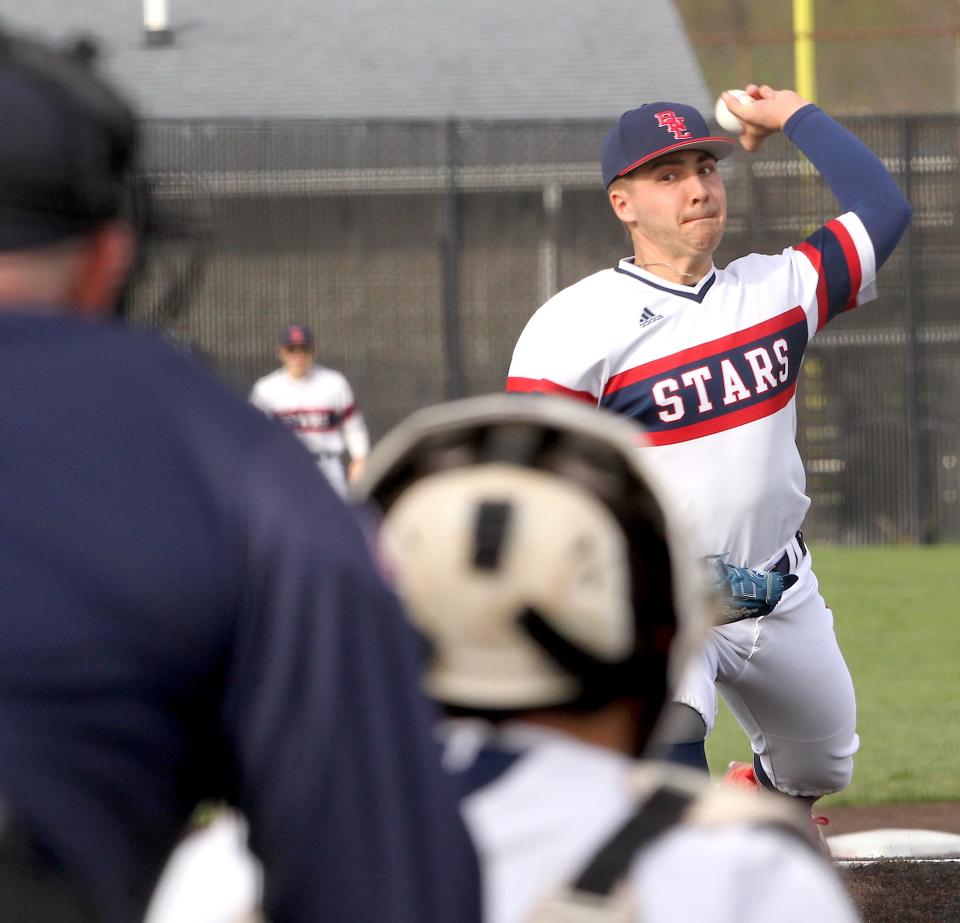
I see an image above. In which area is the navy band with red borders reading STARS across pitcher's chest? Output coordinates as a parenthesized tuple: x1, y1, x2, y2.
(600, 307, 808, 445)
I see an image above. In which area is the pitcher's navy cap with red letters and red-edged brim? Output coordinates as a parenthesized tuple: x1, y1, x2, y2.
(600, 103, 734, 186)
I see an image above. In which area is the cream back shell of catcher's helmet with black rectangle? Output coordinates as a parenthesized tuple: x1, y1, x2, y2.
(381, 464, 635, 709)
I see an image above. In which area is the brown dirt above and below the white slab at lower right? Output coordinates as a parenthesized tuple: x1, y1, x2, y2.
(824, 802, 960, 923)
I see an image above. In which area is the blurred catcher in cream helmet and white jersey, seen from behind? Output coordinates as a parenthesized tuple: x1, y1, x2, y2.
(359, 395, 856, 923)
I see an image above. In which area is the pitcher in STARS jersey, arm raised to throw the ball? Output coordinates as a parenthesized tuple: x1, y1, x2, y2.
(507, 85, 910, 832)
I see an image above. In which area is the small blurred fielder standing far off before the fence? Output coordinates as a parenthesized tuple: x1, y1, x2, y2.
(250, 324, 370, 497)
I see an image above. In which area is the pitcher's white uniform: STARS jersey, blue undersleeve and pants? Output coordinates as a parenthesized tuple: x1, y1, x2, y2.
(507, 97, 910, 797)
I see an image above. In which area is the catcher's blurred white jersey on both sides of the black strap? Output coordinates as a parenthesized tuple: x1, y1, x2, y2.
(445, 721, 857, 923)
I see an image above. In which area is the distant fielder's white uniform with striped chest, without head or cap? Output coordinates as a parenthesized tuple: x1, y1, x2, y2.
(250, 365, 370, 496)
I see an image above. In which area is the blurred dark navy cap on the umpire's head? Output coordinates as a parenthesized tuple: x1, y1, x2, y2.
(0, 29, 137, 251)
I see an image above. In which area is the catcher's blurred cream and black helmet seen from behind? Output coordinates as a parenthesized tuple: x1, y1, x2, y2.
(357, 395, 707, 711)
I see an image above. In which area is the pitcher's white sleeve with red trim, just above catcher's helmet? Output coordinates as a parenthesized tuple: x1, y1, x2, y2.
(506, 304, 605, 405)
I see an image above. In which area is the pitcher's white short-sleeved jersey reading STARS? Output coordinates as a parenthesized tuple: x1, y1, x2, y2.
(508, 213, 876, 567)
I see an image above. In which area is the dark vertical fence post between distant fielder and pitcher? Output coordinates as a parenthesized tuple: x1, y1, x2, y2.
(441, 119, 466, 400)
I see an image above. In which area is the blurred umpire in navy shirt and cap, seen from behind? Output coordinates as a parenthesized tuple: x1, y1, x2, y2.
(0, 27, 478, 923)
